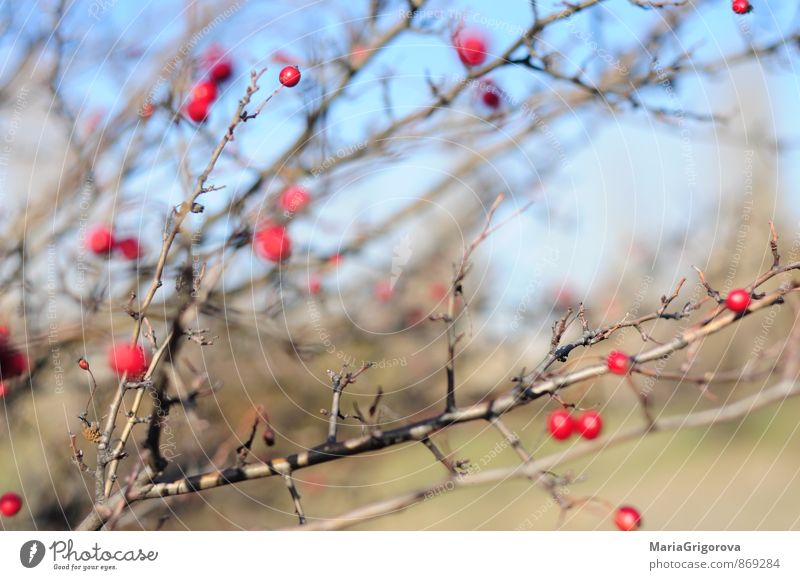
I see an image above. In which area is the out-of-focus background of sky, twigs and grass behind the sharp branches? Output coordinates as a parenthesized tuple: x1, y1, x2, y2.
(0, 0, 800, 530)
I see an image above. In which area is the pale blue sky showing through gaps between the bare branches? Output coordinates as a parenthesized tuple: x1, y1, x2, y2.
(3, 0, 800, 328)
